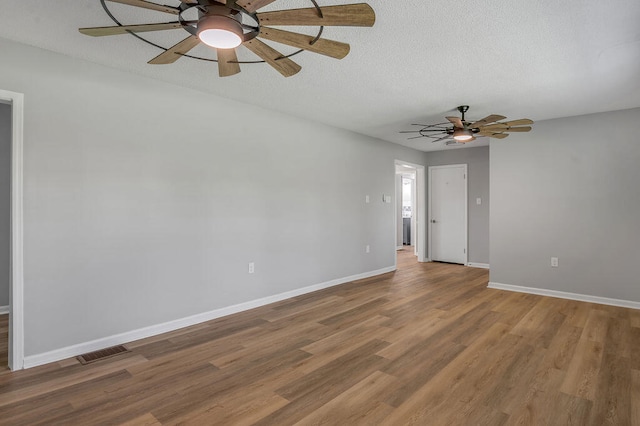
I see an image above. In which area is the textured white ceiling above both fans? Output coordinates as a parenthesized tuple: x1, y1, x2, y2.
(0, 0, 640, 151)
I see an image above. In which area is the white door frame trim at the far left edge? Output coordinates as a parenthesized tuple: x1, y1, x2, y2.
(0, 90, 24, 371)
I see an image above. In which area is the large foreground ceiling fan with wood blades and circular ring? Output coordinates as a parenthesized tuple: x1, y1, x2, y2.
(79, 0, 375, 77)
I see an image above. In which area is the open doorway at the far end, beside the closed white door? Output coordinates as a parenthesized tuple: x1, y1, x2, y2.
(394, 160, 427, 268)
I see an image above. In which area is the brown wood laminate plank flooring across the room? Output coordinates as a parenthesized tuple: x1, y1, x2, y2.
(0, 249, 640, 426)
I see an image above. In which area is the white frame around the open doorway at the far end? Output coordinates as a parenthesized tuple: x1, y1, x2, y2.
(393, 160, 429, 268)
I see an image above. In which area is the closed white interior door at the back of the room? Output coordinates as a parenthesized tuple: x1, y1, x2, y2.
(429, 164, 467, 264)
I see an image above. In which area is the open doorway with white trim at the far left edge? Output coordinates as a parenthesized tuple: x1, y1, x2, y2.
(0, 90, 24, 371)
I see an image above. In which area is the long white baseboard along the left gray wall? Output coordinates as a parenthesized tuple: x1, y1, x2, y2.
(24, 266, 396, 368)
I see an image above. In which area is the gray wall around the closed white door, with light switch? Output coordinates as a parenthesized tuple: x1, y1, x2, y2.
(425, 146, 493, 267)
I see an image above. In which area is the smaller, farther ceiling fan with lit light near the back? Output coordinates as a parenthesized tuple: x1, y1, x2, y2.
(400, 105, 533, 145)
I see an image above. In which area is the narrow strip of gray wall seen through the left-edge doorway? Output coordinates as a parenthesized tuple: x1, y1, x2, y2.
(0, 103, 11, 306)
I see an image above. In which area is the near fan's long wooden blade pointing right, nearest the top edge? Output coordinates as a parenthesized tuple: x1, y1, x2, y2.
(258, 3, 376, 27)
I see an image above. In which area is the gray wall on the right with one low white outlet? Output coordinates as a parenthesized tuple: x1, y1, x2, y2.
(491, 108, 640, 302)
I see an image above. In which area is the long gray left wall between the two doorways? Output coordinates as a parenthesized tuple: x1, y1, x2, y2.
(0, 39, 423, 355)
